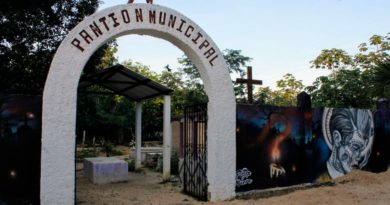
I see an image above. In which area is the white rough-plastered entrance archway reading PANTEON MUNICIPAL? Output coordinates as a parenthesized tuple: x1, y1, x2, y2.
(41, 4, 236, 204)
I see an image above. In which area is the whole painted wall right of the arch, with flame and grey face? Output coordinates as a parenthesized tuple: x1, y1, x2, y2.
(236, 105, 390, 191)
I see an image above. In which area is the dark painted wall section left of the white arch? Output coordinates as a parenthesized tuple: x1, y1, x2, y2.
(0, 94, 42, 204)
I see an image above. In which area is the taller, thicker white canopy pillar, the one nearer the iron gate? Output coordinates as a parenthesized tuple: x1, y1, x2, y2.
(163, 95, 172, 181)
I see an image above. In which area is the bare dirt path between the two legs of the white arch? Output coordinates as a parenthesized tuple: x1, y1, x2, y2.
(76, 168, 200, 205)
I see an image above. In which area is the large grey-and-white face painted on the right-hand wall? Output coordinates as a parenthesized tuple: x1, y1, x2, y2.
(323, 109, 374, 178)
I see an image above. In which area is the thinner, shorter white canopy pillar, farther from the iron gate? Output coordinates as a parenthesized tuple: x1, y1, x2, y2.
(135, 102, 142, 169)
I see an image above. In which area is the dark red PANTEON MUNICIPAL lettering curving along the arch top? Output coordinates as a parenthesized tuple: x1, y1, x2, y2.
(70, 7, 219, 66)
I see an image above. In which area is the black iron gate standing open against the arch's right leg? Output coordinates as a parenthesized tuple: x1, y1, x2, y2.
(183, 104, 208, 201)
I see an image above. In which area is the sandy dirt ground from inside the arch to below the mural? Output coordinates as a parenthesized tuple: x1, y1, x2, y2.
(76, 162, 390, 205)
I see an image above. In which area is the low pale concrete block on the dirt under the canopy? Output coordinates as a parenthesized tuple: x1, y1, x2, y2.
(84, 157, 128, 184)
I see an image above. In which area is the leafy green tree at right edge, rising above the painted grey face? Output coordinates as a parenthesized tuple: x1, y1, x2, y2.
(306, 33, 390, 108)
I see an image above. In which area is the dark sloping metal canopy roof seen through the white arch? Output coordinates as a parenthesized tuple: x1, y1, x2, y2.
(79, 64, 173, 102)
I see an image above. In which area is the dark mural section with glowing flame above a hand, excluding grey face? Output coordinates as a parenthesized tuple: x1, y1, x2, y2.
(236, 105, 331, 191)
